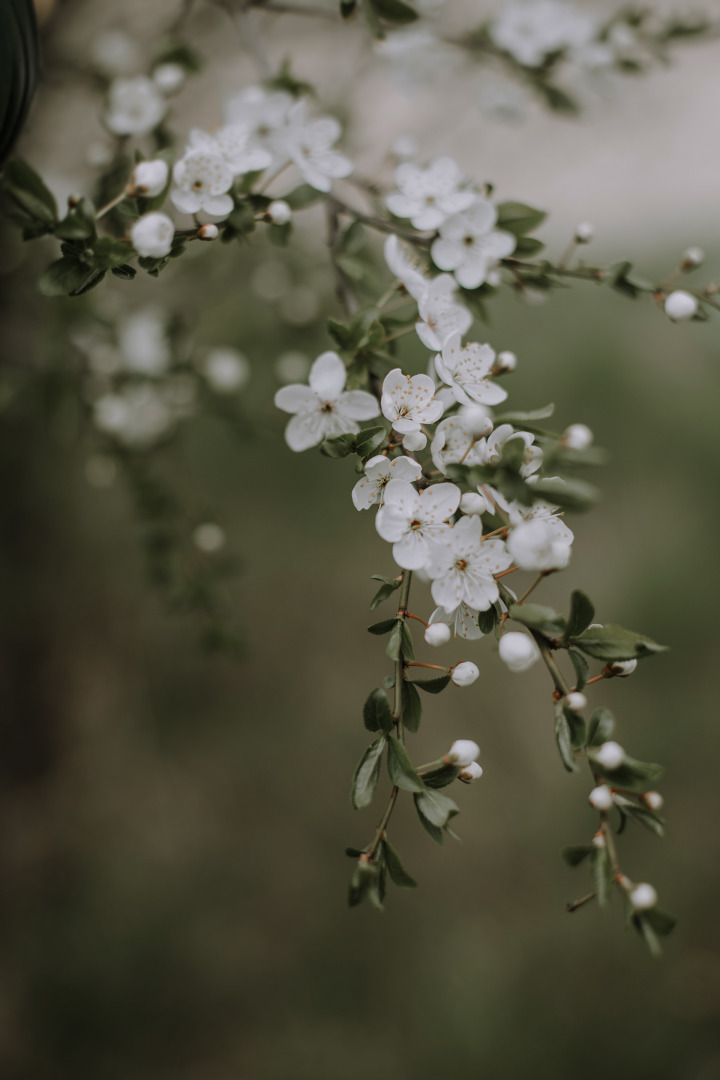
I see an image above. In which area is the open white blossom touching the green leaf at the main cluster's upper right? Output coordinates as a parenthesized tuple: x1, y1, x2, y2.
(431, 198, 517, 288)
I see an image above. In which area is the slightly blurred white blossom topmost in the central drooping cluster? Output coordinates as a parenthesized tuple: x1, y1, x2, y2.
(385, 157, 476, 230)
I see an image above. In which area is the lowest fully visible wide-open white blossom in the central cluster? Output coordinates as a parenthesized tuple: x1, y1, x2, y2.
(425, 517, 512, 611)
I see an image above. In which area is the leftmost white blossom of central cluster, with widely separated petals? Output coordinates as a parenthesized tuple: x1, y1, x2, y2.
(275, 352, 379, 451)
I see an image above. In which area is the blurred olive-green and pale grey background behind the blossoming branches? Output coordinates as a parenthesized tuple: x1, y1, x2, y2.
(0, 0, 720, 1080)
